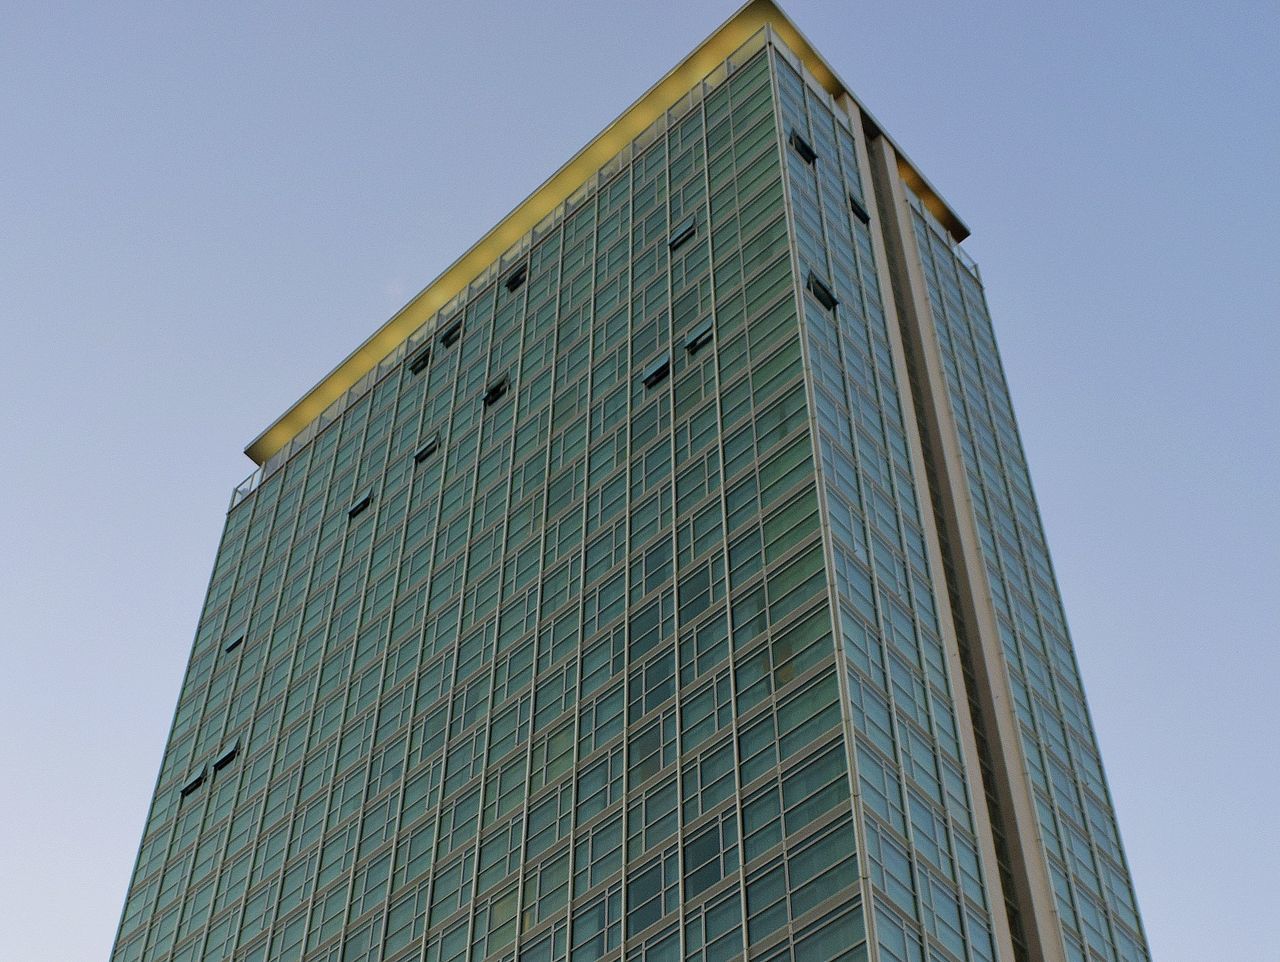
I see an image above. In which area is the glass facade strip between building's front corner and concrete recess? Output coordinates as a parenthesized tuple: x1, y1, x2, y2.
(778, 48, 995, 962)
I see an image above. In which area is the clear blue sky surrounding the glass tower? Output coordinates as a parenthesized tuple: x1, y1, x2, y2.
(0, 0, 1280, 962)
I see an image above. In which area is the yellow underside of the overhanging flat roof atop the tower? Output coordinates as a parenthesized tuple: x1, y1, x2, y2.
(244, 0, 969, 464)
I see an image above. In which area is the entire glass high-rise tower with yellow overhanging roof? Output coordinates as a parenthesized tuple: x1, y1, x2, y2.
(113, 1, 1148, 962)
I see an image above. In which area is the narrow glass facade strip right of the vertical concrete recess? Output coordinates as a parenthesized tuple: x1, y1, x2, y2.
(911, 202, 1149, 962)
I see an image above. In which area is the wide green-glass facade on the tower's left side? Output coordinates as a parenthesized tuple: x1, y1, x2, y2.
(114, 41, 863, 962)
